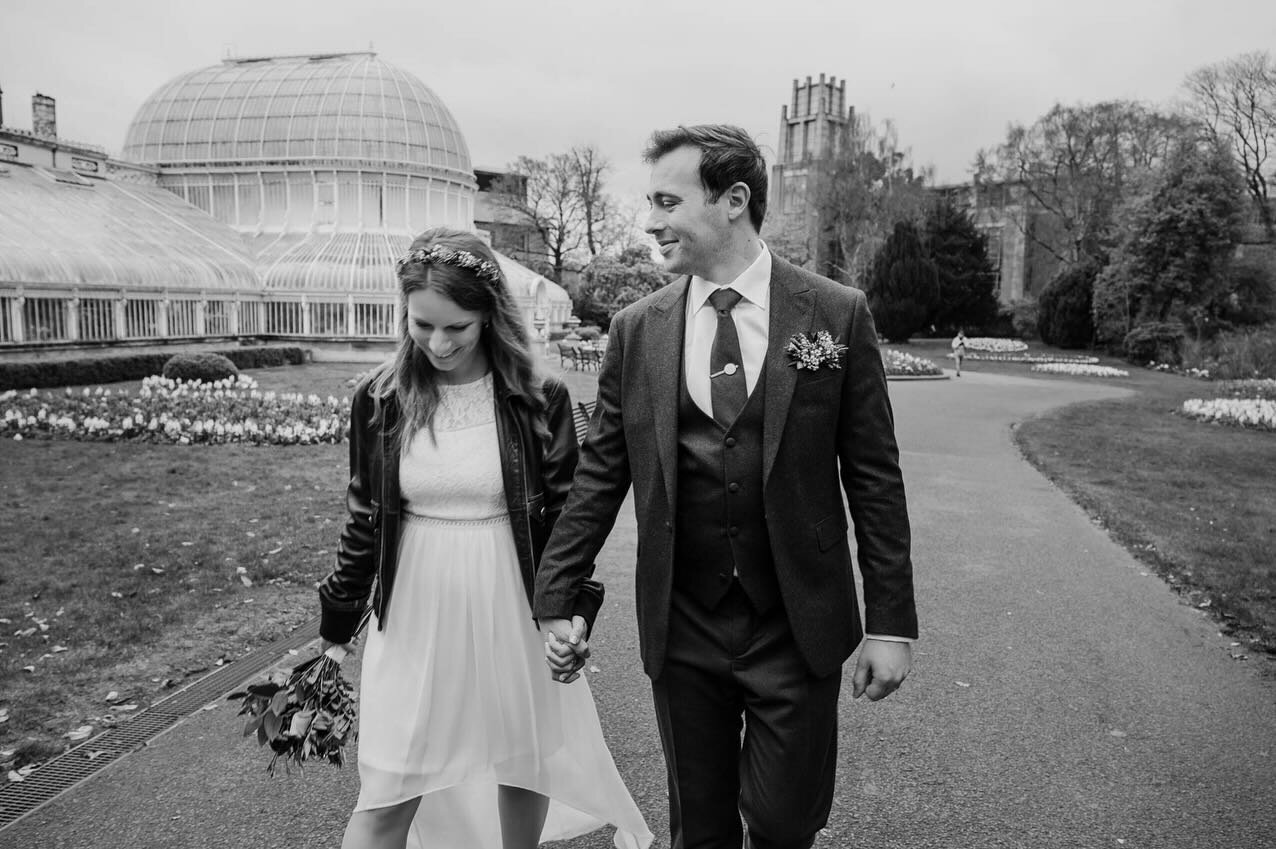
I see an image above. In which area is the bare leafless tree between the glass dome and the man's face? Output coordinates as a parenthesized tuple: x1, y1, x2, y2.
(493, 153, 584, 281)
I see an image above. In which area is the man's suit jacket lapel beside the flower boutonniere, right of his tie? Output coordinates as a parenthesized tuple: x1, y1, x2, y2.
(762, 255, 815, 486)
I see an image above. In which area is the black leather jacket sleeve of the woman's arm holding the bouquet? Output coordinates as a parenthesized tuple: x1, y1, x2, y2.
(319, 383, 380, 643)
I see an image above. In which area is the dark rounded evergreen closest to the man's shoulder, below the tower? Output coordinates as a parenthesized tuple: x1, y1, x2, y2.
(865, 221, 939, 342)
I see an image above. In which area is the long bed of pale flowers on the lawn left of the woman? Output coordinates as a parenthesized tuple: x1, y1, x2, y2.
(0, 375, 350, 446)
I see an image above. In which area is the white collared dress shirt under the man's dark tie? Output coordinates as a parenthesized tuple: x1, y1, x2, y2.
(683, 245, 771, 416)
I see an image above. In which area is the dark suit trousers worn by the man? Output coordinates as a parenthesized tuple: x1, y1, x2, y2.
(652, 582, 842, 849)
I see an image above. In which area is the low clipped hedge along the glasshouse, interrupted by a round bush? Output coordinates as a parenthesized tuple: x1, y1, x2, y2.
(0, 347, 306, 392)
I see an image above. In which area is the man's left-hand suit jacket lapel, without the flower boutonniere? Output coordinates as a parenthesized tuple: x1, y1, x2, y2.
(642, 277, 690, 507)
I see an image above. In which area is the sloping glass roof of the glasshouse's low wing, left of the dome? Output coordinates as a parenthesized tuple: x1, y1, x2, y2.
(0, 166, 260, 291)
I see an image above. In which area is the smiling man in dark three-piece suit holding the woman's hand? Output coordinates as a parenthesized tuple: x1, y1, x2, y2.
(533, 125, 917, 849)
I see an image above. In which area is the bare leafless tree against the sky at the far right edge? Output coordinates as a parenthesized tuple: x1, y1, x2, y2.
(1183, 51, 1276, 236)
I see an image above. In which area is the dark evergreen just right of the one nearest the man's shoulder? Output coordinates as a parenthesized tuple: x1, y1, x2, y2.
(925, 198, 998, 334)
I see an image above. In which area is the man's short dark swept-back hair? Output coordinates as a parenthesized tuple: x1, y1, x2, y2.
(643, 124, 767, 232)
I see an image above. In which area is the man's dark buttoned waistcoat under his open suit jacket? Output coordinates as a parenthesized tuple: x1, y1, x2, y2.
(674, 372, 780, 613)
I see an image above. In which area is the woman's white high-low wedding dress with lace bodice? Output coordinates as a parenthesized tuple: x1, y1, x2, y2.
(356, 375, 652, 849)
